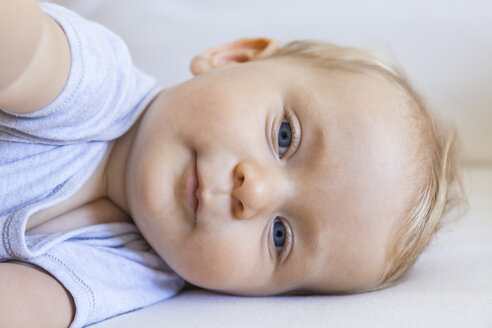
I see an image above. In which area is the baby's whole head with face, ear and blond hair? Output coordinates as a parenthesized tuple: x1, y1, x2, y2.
(126, 39, 461, 295)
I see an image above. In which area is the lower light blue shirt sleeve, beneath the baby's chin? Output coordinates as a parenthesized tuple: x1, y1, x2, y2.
(24, 223, 184, 328)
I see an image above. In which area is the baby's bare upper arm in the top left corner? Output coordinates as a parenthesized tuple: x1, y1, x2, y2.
(0, 0, 70, 113)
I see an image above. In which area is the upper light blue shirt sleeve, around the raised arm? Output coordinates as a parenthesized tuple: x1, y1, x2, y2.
(0, 3, 159, 145)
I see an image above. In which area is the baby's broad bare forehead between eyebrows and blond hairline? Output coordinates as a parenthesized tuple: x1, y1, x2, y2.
(276, 65, 416, 290)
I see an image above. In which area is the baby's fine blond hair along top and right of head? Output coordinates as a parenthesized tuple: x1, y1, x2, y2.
(274, 41, 468, 292)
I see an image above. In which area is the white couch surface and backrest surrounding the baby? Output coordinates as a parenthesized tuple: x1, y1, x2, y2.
(47, 0, 492, 328)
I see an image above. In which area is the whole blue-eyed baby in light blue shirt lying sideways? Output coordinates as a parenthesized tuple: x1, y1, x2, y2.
(0, 0, 461, 327)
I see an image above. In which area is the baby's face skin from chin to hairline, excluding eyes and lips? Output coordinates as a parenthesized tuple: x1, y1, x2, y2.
(108, 53, 416, 296)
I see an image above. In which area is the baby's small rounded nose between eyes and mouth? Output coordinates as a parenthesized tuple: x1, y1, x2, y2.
(232, 162, 283, 219)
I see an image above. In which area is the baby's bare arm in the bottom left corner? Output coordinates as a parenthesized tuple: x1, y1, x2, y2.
(0, 262, 75, 328)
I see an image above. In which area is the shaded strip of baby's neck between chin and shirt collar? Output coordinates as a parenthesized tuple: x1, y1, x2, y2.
(104, 115, 143, 215)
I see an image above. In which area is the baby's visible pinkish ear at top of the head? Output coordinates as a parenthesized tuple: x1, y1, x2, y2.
(190, 38, 279, 75)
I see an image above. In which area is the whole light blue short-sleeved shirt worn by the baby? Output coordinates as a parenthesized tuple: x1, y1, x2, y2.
(0, 3, 184, 327)
